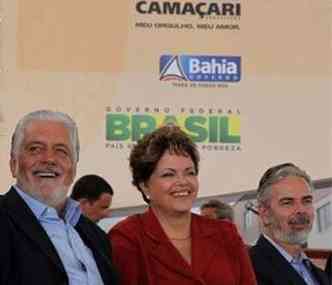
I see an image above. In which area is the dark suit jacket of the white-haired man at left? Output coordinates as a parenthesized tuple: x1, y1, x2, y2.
(0, 188, 117, 285)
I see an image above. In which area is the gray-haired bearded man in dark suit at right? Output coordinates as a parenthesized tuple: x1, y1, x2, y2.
(250, 163, 330, 285)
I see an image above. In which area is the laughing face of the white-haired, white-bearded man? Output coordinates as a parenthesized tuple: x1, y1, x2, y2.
(10, 120, 76, 210)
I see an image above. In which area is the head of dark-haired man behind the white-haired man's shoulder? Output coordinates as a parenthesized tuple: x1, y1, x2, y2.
(71, 174, 114, 223)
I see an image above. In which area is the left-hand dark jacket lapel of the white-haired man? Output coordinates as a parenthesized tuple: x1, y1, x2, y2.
(3, 188, 65, 273)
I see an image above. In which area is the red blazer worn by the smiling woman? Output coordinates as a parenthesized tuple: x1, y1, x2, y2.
(110, 206, 256, 285)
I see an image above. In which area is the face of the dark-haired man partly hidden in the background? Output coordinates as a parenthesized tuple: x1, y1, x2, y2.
(80, 193, 112, 223)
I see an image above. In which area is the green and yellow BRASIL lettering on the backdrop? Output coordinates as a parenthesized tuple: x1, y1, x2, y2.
(106, 113, 241, 144)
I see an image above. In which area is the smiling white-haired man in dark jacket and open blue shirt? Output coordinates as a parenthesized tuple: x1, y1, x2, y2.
(0, 110, 118, 285)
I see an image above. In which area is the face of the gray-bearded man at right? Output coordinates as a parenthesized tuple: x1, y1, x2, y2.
(259, 176, 314, 245)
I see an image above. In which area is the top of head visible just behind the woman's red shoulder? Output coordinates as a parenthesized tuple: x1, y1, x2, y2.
(200, 200, 234, 222)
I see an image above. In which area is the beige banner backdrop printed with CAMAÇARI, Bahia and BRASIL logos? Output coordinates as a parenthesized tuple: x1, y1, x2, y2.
(0, 0, 332, 207)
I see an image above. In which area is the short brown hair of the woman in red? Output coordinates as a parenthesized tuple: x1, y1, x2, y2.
(129, 124, 199, 203)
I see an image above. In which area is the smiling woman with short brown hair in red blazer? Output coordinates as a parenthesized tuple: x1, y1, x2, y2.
(109, 125, 256, 285)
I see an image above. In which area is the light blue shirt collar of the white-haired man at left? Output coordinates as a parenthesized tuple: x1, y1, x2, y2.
(14, 185, 82, 226)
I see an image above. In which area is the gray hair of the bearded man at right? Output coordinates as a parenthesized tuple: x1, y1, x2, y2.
(257, 162, 314, 205)
